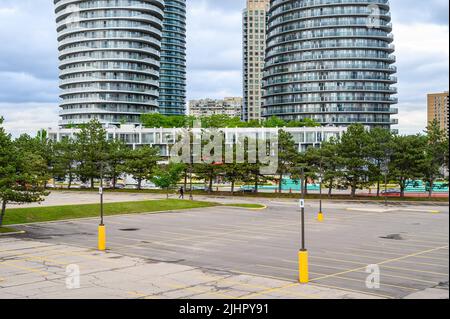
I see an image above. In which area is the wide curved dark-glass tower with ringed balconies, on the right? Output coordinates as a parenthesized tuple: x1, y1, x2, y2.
(263, 0, 397, 128)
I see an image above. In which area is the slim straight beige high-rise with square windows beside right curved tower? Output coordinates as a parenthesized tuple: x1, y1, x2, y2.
(242, 0, 270, 121)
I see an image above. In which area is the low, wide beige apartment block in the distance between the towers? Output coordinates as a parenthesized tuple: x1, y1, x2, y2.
(189, 97, 242, 117)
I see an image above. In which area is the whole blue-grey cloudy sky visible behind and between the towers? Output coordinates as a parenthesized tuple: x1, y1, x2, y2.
(0, 0, 449, 136)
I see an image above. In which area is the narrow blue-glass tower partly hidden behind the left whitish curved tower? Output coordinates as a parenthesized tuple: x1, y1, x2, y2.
(159, 0, 186, 115)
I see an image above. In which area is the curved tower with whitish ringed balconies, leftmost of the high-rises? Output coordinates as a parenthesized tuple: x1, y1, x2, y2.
(54, 0, 164, 126)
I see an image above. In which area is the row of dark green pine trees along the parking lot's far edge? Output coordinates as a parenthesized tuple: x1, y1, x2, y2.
(0, 116, 449, 225)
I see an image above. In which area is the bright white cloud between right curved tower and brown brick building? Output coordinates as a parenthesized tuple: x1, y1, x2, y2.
(394, 23, 449, 134)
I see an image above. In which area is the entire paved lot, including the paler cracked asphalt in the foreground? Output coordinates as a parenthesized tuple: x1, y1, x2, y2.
(0, 194, 449, 299)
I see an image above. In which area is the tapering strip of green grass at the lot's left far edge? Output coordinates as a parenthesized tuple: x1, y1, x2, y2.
(0, 199, 220, 228)
